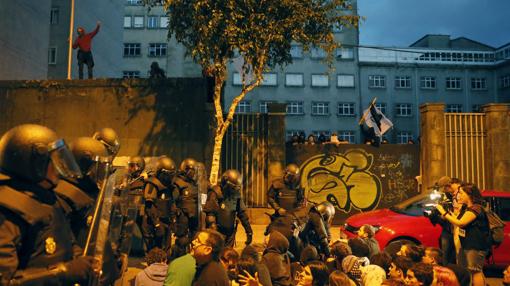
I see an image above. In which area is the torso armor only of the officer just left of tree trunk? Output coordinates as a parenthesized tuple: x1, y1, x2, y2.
(174, 175, 198, 217)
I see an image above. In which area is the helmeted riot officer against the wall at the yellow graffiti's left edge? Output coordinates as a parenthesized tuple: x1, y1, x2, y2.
(267, 164, 304, 215)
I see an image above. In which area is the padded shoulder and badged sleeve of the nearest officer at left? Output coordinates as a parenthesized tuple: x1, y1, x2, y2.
(0, 181, 74, 271)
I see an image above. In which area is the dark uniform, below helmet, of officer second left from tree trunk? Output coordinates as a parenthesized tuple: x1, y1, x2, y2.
(142, 176, 175, 250)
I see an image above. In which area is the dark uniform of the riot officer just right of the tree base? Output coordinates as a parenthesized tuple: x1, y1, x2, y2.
(204, 186, 253, 247)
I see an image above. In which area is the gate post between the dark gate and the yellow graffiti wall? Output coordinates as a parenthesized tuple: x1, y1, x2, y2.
(267, 103, 286, 186)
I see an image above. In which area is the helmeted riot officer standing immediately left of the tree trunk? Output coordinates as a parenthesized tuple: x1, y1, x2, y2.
(174, 158, 200, 238)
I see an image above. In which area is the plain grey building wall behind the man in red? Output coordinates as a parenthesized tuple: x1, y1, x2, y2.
(48, 0, 125, 79)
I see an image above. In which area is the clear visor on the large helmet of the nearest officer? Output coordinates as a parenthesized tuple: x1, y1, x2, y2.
(48, 139, 82, 179)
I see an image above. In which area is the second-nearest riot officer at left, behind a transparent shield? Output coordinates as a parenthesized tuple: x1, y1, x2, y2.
(55, 137, 119, 285)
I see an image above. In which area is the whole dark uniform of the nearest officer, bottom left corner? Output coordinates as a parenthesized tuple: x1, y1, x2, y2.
(0, 173, 81, 285)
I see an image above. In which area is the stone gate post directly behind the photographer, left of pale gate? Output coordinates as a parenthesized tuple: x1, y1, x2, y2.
(420, 103, 446, 190)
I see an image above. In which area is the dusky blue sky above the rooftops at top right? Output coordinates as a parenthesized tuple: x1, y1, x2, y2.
(358, 0, 510, 48)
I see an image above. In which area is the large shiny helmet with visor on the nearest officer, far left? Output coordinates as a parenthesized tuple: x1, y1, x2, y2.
(0, 124, 81, 183)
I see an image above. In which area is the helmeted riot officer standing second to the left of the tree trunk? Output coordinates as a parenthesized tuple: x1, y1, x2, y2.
(142, 156, 177, 250)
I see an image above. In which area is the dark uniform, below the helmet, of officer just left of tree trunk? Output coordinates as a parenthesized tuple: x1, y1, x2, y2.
(173, 174, 199, 238)
